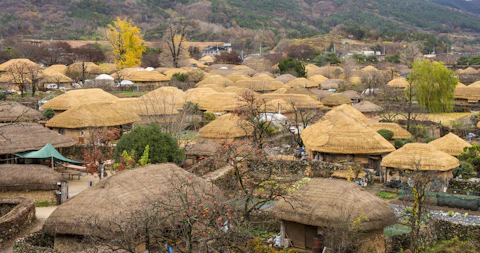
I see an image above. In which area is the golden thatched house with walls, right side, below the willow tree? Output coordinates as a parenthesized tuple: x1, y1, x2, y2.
(381, 143, 460, 190)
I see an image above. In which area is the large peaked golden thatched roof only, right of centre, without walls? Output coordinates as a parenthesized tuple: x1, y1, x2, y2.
(301, 111, 395, 155)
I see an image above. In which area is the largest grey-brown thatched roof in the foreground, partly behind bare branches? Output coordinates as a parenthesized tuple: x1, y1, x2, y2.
(43, 163, 222, 237)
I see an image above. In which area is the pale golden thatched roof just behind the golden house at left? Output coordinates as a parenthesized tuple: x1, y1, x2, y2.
(42, 89, 119, 111)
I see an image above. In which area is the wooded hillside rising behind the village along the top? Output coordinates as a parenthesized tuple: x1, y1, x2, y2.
(0, 0, 480, 48)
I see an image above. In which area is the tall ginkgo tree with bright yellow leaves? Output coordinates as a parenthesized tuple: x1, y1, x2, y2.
(106, 18, 146, 69)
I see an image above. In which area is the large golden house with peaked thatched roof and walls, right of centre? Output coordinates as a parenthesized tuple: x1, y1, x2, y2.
(301, 110, 395, 170)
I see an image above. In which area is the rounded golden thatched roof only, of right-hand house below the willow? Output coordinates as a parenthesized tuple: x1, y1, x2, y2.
(381, 143, 460, 171)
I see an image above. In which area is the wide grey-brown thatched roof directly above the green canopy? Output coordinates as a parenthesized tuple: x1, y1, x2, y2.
(0, 123, 77, 154)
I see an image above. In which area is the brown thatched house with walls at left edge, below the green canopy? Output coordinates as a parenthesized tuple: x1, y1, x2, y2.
(0, 164, 68, 204)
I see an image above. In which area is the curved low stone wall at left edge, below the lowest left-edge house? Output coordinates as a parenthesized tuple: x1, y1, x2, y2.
(0, 198, 35, 246)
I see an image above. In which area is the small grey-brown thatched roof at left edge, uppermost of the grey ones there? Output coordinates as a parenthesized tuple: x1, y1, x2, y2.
(0, 101, 43, 122)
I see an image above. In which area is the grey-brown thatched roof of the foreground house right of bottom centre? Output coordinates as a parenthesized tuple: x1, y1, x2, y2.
(268, 178, 396, 231)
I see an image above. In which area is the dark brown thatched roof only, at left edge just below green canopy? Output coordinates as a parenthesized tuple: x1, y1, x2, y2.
(0, 164, 65, 191)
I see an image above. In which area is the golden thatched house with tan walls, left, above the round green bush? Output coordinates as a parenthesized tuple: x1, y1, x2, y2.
(46, 102, 142, 143)
